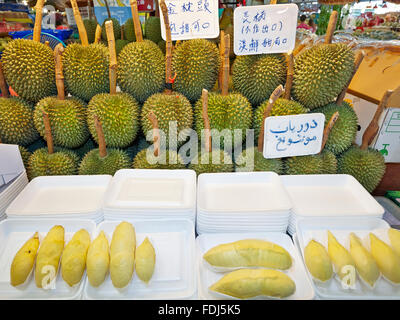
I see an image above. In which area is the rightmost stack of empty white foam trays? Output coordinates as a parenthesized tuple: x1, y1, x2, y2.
(281, 174, 385, 235)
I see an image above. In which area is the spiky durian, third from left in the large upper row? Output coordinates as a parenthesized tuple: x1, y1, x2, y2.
(117, 40, 165, 103)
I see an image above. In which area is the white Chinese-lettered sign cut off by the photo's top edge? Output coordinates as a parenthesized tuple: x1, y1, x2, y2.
(160, 0, 219, 41)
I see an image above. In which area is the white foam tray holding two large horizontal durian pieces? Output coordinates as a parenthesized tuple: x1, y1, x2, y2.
(196, 232, 315, 300)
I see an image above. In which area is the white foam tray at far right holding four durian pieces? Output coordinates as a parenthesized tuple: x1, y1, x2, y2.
(296, 218, 400, 299)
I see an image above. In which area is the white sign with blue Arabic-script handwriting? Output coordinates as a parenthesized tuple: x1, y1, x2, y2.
(263, 113, 325, 159)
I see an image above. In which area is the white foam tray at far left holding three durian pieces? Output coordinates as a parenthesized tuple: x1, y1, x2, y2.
(0, 219, 96, 300)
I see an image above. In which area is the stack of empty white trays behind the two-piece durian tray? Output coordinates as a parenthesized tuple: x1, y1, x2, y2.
(196, 172, 291, 234)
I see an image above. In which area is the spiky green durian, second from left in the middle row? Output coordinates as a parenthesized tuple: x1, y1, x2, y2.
(33, 97, 89, 148)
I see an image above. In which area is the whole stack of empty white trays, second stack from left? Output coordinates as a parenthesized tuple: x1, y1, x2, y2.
(103, 169, 196, 224)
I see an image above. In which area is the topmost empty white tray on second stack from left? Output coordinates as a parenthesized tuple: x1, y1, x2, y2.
(104, 169, 196, 212)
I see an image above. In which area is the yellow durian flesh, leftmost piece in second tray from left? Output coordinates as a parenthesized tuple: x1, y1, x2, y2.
(86, 231, 110, 287)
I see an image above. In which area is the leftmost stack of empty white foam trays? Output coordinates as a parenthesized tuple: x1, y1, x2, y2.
(6, 175, 111, 223)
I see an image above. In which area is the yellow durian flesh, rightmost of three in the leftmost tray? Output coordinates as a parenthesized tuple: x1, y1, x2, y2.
(61, 229, 90, 287)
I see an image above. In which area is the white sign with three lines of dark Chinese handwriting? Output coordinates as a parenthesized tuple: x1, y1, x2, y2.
(233, 3, 299, 56)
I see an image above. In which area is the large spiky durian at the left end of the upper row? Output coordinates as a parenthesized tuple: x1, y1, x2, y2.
(1, 39, 57, 103)
